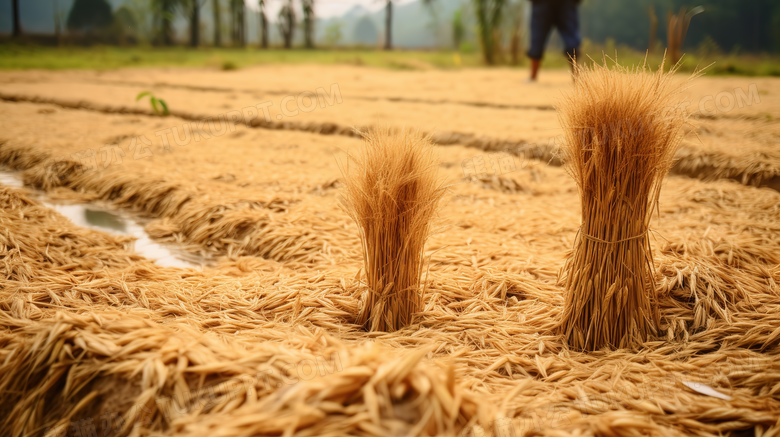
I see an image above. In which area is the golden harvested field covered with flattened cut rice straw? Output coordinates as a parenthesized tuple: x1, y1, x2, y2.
(0, 65, 780, 437)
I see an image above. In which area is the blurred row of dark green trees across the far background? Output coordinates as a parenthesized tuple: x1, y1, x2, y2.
(6, 0, 780, 57)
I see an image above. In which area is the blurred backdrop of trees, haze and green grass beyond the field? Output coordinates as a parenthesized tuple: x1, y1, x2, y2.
(0, 0, 780, 76)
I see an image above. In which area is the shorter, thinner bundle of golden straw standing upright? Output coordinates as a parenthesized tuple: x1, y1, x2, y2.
(341, 128, 445, 332)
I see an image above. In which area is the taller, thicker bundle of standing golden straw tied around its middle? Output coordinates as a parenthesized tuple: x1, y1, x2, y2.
(558, 60, 696, 350)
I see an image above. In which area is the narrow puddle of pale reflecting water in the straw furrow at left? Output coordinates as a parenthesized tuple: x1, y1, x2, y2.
(0, 171, 203, 270)
